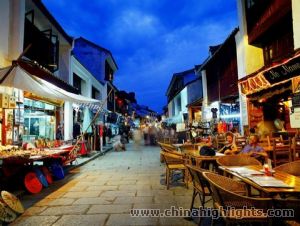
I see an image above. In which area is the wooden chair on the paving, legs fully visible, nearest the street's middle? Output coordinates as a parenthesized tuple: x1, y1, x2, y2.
(161, 151, 188, 189)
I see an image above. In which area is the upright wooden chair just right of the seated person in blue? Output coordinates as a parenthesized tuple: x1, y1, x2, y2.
(273, 138, 292, 167)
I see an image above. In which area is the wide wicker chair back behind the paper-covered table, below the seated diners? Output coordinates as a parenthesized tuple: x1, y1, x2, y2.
(217, 155, 262, 166)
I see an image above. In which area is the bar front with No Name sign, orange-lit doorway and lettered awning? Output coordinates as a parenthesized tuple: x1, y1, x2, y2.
(239, 53, 300, 136)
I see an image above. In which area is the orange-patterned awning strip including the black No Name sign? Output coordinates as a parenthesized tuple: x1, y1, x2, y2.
(239, 52, 300, 95)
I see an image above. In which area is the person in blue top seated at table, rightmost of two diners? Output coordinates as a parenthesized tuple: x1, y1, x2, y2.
(240, 134, 268, 161)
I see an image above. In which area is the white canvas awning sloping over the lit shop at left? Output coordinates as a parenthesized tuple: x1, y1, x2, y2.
(0, 64, 100, 104)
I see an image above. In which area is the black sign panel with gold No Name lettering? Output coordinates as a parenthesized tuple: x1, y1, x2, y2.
(263, 56, 300, 84)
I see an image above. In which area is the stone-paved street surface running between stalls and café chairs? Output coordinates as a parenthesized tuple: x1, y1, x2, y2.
(12, 144, 211, 226)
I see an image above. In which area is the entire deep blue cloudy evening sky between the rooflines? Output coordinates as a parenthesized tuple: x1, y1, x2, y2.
(43, 0, 238, 112)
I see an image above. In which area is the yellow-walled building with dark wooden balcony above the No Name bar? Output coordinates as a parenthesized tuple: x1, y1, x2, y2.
(236, 0, 300, 135)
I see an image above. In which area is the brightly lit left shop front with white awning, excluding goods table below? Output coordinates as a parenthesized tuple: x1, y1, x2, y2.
(0, 61, 100, 145)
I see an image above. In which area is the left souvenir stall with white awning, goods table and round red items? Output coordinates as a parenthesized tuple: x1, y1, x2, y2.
(0, 60, 99, 193)
